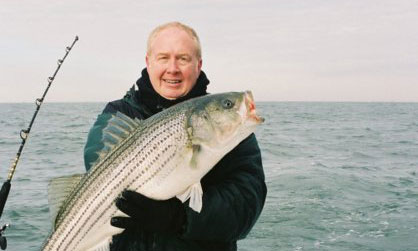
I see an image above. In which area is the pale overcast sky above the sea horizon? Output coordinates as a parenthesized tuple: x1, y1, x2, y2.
(0, 0, 418, 103)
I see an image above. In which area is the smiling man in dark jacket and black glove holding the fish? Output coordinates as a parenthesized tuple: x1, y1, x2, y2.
(84, 22, 267, 251)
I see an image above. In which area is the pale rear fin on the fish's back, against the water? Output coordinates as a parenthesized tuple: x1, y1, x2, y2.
(48, 174, 84, 226)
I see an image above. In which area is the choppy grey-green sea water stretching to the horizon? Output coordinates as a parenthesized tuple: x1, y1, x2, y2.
(0, 102, 418, 251)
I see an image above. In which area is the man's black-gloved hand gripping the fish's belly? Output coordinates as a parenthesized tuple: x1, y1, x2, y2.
(110, 190, 186, 233)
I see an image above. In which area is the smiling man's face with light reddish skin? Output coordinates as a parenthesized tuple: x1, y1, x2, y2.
(145, 27, 202, 99)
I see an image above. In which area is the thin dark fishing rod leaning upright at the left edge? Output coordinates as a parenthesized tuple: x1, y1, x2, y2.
(0, 36, 78, 250)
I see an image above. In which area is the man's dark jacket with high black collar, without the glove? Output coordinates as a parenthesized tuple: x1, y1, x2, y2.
(84, 69, 267, 251)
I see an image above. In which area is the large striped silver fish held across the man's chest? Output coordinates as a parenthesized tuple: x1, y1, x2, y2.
(42, 91, 264, 251)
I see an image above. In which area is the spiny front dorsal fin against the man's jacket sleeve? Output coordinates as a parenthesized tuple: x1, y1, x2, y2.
(92, 112, 141, 166)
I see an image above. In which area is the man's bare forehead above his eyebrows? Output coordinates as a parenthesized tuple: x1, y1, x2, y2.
(150, 27, 197, 54)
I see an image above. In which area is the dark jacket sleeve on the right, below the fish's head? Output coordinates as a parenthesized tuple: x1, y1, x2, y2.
(182, 134, 267, 241)
